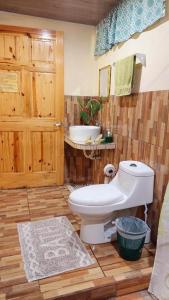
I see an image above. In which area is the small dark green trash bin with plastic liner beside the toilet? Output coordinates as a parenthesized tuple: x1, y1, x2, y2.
(115, 217, 148, 260)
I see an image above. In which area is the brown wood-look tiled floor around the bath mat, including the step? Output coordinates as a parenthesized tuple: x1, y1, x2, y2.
(0, 187, 154, 300)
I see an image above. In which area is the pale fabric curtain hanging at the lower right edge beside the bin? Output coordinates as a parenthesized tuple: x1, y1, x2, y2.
(148, 183, 169, 300)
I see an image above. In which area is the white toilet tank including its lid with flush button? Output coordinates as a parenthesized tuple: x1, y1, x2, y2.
(111, 160, 154, 206)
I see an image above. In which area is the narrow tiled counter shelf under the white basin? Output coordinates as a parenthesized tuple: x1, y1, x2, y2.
(65, 136, 115, 151)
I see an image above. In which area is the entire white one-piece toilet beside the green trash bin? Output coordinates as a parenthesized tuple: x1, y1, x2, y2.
(69, 161, 154, 244)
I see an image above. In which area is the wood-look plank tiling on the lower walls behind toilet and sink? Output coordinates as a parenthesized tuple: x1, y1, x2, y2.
(65, 91, 169, 241)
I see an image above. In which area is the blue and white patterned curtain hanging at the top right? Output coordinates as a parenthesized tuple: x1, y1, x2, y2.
(95, 0, 165, 55)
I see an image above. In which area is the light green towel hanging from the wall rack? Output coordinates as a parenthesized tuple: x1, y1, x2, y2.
(115, 55, 135, 96)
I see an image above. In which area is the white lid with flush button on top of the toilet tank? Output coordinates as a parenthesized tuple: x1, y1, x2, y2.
(119, 160, 154, 177)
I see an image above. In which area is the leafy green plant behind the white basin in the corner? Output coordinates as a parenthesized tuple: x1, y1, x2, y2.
(78, 98, 102, 125)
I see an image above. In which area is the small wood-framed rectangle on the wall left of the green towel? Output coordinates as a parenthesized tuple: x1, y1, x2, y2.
(99, 65, 111, 97)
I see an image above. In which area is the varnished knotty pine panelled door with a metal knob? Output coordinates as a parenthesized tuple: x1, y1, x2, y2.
(0, 25, 64, 188)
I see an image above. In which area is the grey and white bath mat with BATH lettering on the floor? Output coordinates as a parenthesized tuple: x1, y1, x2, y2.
(17, 216, 95, 281)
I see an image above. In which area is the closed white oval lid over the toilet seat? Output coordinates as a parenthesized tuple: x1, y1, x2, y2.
(69, 184, 123, 206)
